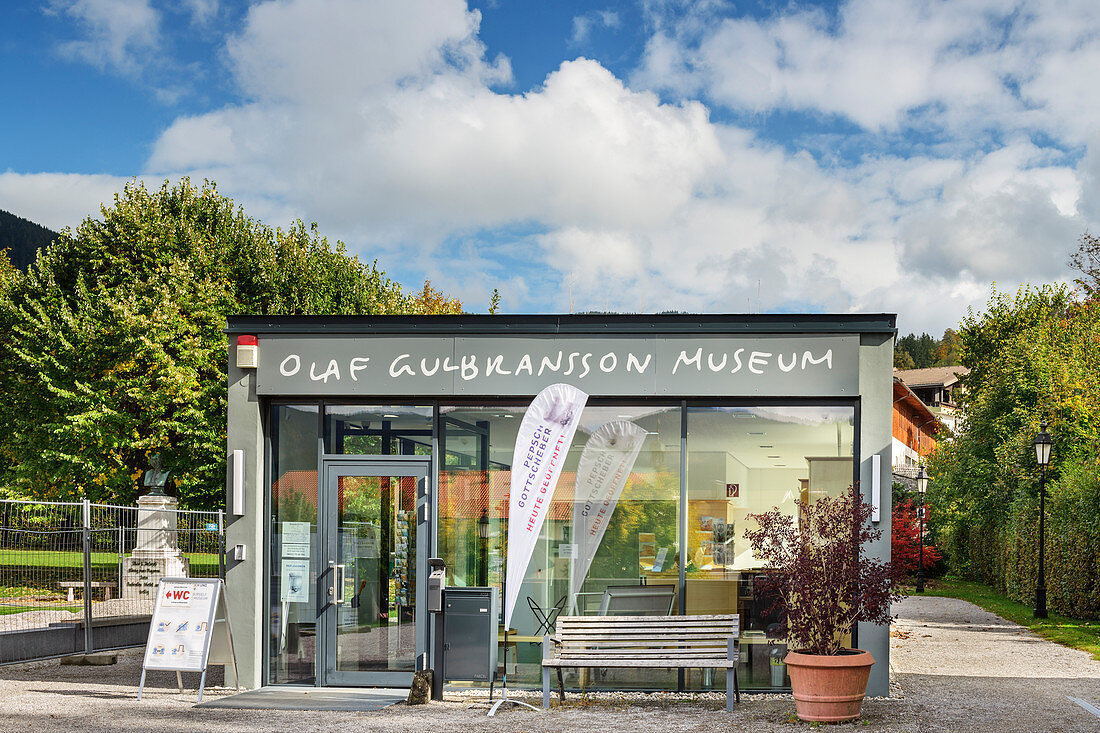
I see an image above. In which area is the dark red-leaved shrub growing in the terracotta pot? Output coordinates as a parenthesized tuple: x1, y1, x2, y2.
(745, 488, 902, 655)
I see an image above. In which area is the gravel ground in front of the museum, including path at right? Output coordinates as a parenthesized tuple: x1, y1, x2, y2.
(0, 598, 1100, 733)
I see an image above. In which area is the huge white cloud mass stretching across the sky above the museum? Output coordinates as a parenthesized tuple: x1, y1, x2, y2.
(19, 0, 1100, 332)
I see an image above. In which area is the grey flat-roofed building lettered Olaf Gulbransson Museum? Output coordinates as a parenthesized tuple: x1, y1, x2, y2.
(227, 314, 895, 696)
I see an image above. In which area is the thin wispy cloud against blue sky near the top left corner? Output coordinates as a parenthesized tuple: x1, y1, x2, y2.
(50, 0, 161, 75)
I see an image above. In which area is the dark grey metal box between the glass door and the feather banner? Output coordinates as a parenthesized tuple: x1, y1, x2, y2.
(443, 588, 499, 682)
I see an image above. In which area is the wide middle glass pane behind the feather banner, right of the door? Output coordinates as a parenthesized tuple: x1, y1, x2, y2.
(439, 405, 677, 688)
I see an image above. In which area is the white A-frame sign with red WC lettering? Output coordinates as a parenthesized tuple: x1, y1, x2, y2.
(138, 578, 237, 702)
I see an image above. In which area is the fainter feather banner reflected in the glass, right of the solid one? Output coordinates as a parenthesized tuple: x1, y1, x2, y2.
(569, 420, 646, 613)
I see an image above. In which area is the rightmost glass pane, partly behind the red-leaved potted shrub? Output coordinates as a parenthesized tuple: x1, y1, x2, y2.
(686, 406, 855, 689)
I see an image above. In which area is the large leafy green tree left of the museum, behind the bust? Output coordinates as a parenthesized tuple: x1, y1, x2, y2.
(0, 179, 461, 507)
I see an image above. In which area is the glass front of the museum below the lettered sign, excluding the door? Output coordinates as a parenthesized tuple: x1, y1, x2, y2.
(268, 400, 856, 689)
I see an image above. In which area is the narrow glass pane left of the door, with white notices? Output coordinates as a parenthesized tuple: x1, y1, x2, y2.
(267, 405, 319, 685)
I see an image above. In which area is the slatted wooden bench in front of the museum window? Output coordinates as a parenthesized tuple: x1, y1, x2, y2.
(542, 614, 741, 710)
